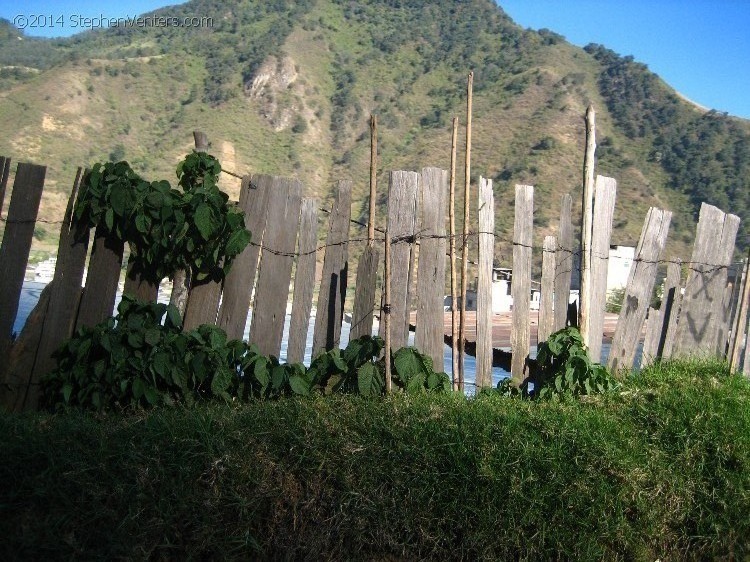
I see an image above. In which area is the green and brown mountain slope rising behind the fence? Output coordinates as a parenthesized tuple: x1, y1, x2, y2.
(0, 0, 750, 264)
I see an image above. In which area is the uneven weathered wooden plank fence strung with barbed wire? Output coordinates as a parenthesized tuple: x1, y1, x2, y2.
(0, 121, 750, 410)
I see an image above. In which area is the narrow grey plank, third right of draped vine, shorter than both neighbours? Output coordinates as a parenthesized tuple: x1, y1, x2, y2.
(286, 199, 320, 363)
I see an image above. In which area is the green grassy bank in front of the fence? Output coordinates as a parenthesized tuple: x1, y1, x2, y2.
(0, 356, 750, 560)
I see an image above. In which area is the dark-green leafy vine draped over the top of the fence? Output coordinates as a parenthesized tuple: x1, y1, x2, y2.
(75, 152, 250, 283)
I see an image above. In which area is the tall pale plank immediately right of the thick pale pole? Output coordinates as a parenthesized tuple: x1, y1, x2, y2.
(587, 176, 617, 363)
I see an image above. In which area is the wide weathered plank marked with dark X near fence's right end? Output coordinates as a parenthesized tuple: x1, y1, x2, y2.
(674, 203, 740, 355)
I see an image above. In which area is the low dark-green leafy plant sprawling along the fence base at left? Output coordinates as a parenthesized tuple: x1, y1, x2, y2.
(43, 310, 450, 411)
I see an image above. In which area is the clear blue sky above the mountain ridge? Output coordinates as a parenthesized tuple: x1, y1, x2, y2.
(0, 0, 750, 119)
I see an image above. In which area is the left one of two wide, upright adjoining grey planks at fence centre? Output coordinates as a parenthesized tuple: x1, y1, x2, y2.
(381, 171, 421, 350)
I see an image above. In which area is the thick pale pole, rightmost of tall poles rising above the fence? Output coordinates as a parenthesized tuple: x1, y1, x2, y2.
(578, 105, 596, 347)
